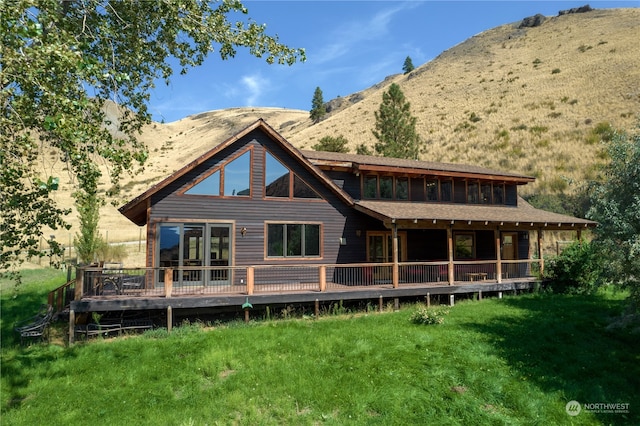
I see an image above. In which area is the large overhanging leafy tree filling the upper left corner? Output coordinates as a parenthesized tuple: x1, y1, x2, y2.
(0, 0, 305, 280)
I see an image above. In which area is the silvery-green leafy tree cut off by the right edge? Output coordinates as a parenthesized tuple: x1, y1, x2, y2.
(588, 125, 640, 310)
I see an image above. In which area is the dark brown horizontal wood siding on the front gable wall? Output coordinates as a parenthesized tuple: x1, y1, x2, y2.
(150, 132, 364, 265)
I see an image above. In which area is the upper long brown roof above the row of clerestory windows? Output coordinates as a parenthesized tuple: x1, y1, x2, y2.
(301, 150, 535, 184)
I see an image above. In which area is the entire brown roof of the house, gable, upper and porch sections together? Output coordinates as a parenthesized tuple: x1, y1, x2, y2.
(119, 119, 597, 229)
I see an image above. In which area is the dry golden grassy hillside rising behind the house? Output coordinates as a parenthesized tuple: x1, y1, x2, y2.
(37, 9, 640, 250)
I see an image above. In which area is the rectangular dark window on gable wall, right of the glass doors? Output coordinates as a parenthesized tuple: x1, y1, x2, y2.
(266, 223, 321, 257)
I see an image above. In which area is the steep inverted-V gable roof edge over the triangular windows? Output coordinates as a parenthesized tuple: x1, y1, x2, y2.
(118, 119, 353, 226)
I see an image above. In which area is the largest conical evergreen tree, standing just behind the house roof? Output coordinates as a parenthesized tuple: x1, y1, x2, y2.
(373, 83, 423, 159)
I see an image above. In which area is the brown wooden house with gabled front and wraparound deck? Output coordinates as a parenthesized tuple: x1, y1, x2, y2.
(62, 120, 596, 336)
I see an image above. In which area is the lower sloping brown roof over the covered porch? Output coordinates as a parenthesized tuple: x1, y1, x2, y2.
(355, 197, 597, 229)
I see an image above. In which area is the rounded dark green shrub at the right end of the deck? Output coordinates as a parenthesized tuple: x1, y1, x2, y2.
(544, 241, 602, 294)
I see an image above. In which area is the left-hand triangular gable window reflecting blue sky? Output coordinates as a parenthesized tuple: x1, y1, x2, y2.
(184, 151, 251, 197)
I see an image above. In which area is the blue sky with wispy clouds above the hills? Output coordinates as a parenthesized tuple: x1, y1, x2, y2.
(150, 0, 640, 122)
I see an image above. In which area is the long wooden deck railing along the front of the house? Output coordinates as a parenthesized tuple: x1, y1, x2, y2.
(75, 259, 540, 298)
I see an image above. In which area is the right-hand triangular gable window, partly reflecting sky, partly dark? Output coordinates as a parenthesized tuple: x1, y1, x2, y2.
(264, 152, 321, 199)
